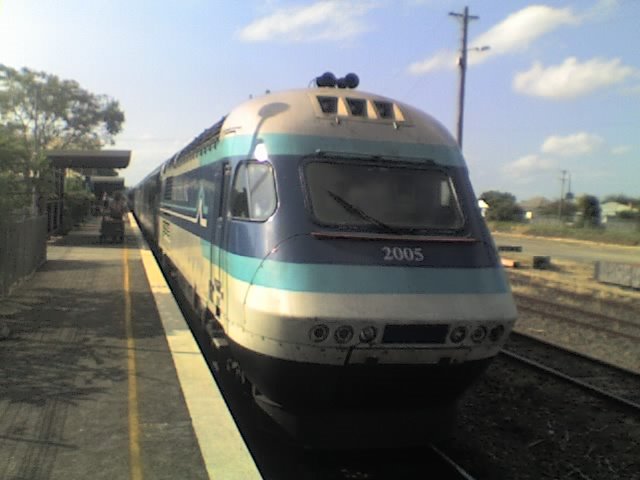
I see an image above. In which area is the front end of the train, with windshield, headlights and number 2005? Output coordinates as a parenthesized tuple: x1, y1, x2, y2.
(222, 83, 516, 444)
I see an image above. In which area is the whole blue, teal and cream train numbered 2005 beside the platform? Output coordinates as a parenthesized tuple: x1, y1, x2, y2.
(131, 73, 517, 444)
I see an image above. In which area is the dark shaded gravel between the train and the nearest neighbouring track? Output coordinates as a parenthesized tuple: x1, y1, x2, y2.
(443, 357, 640, 480)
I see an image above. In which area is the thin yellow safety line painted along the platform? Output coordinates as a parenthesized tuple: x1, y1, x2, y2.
(122, 246, 142, 480)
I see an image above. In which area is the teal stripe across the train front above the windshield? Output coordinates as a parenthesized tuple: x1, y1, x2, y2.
(200, 134, 465, 167)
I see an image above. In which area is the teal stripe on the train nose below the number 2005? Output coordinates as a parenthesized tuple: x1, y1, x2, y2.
(202, 241, 509, 294)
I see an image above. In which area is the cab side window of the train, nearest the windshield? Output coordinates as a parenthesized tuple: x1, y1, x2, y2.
(230, 162, 277, 221)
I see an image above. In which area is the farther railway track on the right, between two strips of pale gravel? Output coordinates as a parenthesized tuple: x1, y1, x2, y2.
(514, 293, 640, 342)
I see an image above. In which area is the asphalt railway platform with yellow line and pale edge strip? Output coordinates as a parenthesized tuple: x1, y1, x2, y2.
(0, 216, 261, 480)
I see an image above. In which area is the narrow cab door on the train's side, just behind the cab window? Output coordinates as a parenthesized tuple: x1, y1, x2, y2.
(209, 162, 231, 326)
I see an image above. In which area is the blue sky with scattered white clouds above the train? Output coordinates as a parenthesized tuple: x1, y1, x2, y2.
(0, 0, 640, 200)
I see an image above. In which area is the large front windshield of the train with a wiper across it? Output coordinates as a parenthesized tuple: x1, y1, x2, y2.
(305, 161, 464, 231)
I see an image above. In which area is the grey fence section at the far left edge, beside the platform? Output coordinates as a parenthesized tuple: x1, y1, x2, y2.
(0, 215, 47, 297)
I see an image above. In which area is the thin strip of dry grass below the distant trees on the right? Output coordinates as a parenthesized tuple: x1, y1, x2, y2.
(489, 222, 640, 246)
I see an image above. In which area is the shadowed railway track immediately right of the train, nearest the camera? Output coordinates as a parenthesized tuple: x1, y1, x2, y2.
(500, 332, 640, 413)
